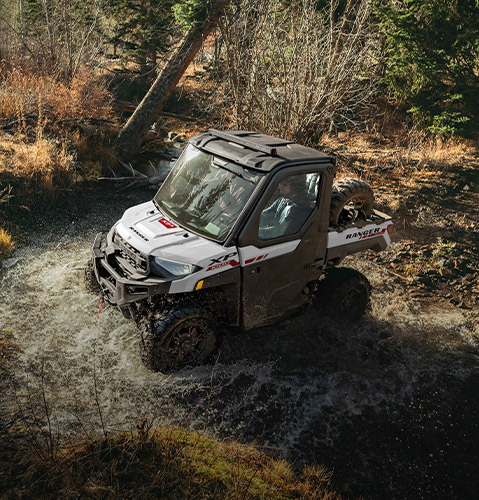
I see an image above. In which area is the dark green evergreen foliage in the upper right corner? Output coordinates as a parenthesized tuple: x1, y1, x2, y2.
(375, 0, 479, 136)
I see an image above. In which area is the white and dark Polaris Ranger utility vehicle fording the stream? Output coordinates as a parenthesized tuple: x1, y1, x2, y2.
(85, 130, 392, 372)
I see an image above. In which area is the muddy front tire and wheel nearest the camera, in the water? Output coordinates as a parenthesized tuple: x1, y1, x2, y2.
(138, 306, 217, 373)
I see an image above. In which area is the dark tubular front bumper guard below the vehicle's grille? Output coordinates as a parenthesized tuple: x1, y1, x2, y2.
(92, 233, 171, 307)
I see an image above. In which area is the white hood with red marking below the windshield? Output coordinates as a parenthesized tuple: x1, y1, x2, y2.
(115, 201, 231, 267)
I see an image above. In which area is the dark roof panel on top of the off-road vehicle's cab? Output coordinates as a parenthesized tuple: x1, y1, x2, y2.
(190, 129, 334, 172)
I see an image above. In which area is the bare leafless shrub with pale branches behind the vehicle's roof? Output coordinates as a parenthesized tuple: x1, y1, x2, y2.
(220, 0, 377, 142)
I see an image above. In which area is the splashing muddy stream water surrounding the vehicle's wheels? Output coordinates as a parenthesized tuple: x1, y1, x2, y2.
(0, 188, 479, 499)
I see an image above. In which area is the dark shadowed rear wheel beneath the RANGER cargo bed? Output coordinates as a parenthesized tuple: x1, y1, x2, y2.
(314, 267, 371, 321)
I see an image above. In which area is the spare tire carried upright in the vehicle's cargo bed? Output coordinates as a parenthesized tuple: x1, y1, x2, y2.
(329, 177, 374, 226)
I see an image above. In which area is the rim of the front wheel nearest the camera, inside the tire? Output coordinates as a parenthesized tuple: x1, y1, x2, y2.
(164, 320, 208, 363)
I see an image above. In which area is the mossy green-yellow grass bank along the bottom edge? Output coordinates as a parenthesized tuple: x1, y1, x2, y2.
(0, 427, 340, 500)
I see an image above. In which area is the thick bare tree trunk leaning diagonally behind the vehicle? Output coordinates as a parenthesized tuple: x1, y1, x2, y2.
(116, 0, 228, 161)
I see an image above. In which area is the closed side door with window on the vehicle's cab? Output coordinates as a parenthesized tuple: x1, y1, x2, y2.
(238, 166, 329, 330)
